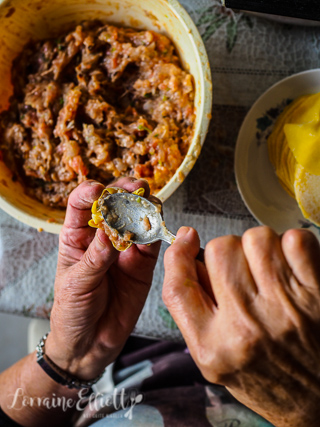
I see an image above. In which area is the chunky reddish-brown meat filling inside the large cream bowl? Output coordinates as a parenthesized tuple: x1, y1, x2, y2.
(0, 21, 195, 208)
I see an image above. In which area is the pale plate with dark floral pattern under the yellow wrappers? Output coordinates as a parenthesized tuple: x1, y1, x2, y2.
(235, 69, 320, 237)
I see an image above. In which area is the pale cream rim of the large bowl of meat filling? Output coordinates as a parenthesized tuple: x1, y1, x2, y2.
(0, 0, 212, 234)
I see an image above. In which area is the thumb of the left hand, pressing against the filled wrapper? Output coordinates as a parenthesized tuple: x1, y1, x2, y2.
(74, 230, 119, 293)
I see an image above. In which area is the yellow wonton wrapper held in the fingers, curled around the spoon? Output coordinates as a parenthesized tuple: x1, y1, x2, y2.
(88, 187, 145, 252)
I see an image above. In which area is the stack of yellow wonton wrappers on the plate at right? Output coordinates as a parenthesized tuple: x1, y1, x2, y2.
(268, 94, 320, 226)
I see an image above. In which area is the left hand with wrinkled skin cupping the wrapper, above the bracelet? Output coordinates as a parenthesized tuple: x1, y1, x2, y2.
(46, 178, 160, 380)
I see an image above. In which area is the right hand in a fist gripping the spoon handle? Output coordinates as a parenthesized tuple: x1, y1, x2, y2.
(163, 227, 320, 427)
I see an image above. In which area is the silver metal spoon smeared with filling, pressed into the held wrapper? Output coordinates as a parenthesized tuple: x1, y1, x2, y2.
(100, 193, 204, 261)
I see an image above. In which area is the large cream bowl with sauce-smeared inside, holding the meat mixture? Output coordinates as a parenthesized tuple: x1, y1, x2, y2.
(0, 0, 212, 233)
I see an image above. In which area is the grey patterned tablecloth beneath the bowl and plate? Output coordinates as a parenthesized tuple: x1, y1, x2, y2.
(0, 0, 320, 340)
